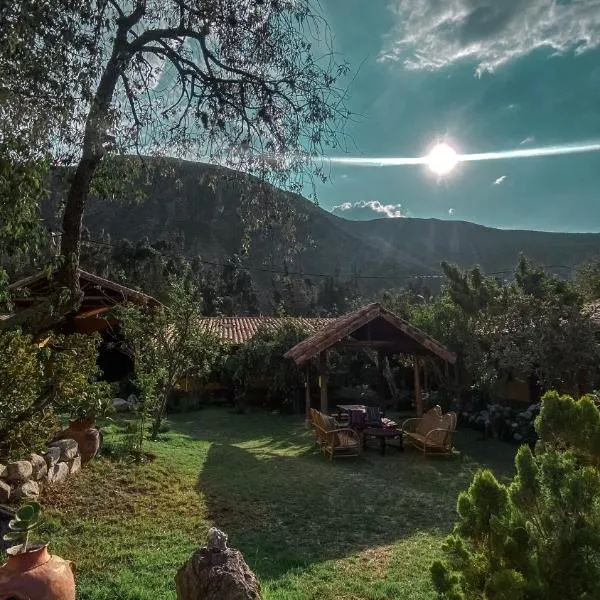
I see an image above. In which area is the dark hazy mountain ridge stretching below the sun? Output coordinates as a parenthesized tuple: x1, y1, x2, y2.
(45, 159, 600, 298)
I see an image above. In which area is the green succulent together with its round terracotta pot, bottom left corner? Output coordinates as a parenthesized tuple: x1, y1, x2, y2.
(0, 502, 75, 600)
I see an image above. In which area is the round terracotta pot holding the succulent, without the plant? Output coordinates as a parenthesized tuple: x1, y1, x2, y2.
(0, 545, 75, 600)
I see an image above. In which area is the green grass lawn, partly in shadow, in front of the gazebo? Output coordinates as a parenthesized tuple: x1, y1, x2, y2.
(38, 409, 514, 600)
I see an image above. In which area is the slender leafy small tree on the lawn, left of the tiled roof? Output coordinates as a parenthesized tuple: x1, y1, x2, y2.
(118, 278, 222, 442)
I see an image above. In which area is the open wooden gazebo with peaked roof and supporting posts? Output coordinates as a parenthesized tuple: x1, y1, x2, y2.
(284, 303, 456, 418)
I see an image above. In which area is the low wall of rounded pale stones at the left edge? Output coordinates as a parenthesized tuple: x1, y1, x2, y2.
(0, 439, 81, 504)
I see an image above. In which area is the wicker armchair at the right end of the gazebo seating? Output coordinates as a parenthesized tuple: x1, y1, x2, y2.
(402, 406, 456, 456)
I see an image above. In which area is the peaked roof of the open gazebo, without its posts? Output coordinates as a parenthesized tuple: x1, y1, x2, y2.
(285, 303, 456, 365)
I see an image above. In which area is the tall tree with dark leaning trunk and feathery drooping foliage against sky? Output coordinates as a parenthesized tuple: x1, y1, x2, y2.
(0, 0, 347, 326)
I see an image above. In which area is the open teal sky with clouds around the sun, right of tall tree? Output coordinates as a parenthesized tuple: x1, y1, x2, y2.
(317, 0, 600, 232)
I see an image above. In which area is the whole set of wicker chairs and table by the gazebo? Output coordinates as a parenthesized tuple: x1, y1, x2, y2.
(310, 404, 456, 460)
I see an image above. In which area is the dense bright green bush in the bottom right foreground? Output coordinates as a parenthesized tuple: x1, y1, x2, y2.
(432, 392, 600, 600)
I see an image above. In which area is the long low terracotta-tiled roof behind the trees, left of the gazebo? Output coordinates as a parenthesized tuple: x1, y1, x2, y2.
(200, 317, 334, 345)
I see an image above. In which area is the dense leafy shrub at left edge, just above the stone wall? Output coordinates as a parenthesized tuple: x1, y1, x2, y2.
(0, 330, 111, 456)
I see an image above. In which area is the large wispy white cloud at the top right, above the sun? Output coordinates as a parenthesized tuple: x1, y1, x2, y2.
(379, 0, 600, 73)
